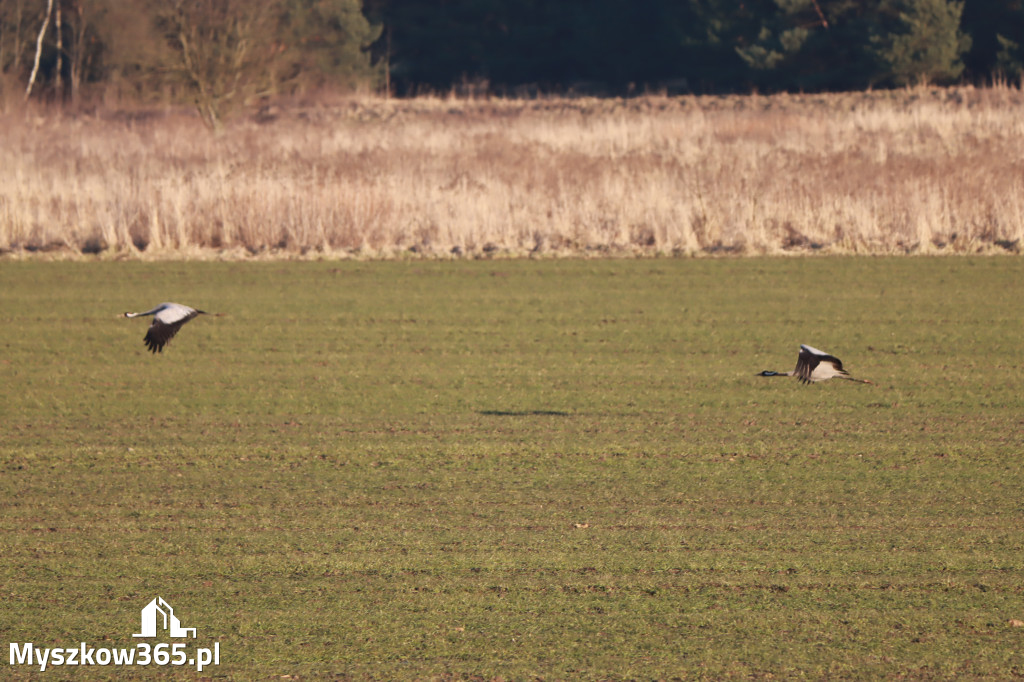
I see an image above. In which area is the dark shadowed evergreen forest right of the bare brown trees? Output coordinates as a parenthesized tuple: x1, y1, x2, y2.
(366, 0, 1024, 95)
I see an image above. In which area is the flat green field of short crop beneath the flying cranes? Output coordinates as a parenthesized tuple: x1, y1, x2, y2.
(0, 257, 1024, 680)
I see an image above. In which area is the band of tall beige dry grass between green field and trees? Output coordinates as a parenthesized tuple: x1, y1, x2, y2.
(0, 86, 1024, 258)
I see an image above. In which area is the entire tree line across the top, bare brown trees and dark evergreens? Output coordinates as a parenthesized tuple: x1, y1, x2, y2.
(0, 0, 1024, 126)
